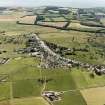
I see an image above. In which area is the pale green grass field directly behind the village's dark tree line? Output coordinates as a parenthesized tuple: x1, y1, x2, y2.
(40, 31, 92, 47)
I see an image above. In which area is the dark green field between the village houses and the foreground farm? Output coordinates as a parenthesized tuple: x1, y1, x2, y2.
(42, 69, 75, 91)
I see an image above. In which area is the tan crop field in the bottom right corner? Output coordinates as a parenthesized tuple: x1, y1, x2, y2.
(81, 87, 105, 105)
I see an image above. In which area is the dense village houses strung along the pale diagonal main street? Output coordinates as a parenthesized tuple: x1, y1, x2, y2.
(18, 34, 105, 75)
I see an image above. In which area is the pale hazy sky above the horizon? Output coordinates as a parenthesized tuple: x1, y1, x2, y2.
(0, 0, 105, 8)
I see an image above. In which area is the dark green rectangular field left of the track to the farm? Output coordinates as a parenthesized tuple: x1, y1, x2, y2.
(13, 79, 41, 98)
